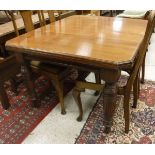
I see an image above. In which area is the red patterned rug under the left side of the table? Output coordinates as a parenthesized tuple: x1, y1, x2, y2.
(0, 69, 83, 144)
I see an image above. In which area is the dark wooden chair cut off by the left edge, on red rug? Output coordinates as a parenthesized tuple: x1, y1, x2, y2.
(0, 56, 21, 109)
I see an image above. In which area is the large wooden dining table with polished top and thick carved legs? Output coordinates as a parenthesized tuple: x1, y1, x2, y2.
(6, 15, 147, 133)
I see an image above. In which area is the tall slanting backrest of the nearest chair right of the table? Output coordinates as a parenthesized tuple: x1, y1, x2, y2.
(128, 11, 155, 86)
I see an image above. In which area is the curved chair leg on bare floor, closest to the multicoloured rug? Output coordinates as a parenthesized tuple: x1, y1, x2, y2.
(73, 88, 83, 122)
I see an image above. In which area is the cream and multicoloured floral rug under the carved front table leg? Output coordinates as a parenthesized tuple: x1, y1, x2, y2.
(75, 78, 155, 144)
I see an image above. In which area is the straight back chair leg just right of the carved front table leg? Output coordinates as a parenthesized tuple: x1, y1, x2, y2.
(124, 91, 130, 133)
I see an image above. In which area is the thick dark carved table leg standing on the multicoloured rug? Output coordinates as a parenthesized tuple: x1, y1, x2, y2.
(101, 69, 121, 133)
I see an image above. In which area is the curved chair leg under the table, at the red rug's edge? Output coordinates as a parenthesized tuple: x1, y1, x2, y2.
(52, 80, 66, 115)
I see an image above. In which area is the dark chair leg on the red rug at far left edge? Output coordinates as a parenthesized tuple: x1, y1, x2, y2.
(0, 82, 10, 110)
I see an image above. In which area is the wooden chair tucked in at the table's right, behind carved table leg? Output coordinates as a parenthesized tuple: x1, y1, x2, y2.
(73, 11, 155, 133)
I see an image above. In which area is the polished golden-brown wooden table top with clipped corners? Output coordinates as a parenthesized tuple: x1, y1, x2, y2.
(6, 15, 147, 67)
